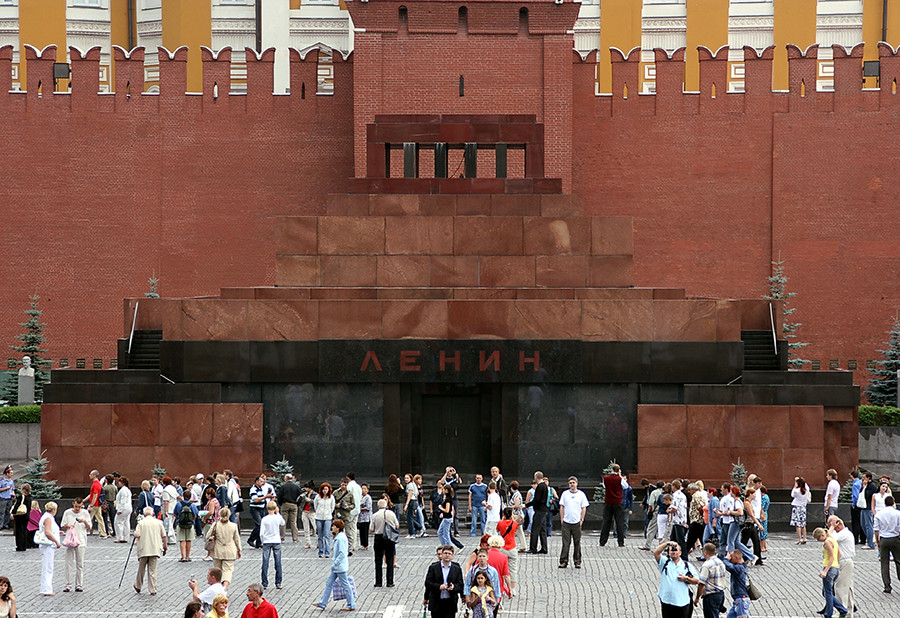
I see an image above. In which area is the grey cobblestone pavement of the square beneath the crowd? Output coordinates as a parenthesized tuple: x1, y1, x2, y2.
(0, 530, 900, 618)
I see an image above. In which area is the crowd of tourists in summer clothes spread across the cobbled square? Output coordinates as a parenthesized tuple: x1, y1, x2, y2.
(0, 465, 900, 618)
